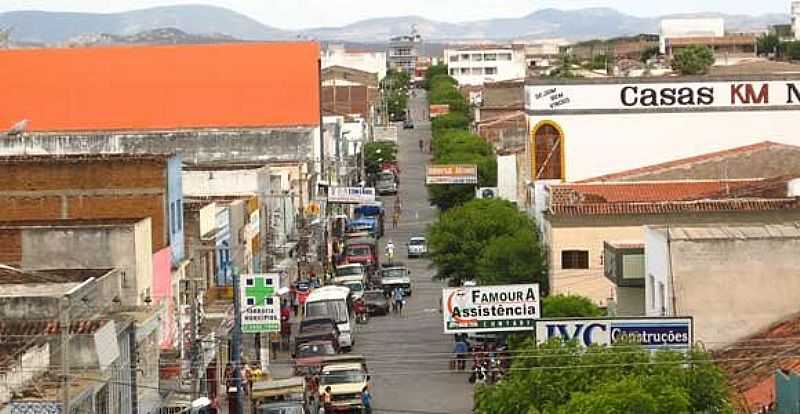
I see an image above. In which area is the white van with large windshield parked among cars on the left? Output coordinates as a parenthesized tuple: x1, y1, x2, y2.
(303, 286, 355, 350)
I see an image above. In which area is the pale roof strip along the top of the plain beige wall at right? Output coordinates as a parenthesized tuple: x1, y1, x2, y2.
(651, 222, 800, 241)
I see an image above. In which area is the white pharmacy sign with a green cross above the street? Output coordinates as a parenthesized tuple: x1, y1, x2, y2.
(239, 273, 281, 333)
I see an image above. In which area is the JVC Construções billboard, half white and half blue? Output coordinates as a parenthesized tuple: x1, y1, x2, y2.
(536, 318, 693, 349)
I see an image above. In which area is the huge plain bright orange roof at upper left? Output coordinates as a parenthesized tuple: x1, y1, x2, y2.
(0, 42, 320, 131)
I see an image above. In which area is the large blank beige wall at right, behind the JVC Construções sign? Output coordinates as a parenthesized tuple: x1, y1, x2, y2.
(652, 231, 800, 349)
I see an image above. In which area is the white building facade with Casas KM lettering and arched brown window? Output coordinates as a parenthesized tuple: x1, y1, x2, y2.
(525, 75, 800, 182)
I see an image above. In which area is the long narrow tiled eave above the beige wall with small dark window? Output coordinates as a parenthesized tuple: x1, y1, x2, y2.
(549, 198, 800, 216)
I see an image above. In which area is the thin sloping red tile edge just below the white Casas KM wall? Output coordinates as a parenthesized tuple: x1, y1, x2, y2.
(579, 141, 800, 183)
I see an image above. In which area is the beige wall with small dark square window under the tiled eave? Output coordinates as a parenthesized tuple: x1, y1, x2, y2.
(544, 210, 800, 304)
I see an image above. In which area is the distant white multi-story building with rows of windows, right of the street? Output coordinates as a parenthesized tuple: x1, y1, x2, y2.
(444, 45, 527, 85)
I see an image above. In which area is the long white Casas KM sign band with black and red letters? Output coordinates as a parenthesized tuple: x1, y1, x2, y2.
(526, 80, 800, 113)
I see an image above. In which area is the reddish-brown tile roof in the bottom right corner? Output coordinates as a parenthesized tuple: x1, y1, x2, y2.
(714, 318, 800, 409)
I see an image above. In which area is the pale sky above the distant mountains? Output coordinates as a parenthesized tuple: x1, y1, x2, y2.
(0, 0, 790, 29)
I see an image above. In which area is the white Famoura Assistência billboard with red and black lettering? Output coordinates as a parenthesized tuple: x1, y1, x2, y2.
(442, 283, 540, 334)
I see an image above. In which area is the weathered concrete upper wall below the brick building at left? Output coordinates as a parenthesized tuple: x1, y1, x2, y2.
(20, 218, 153, 305)
